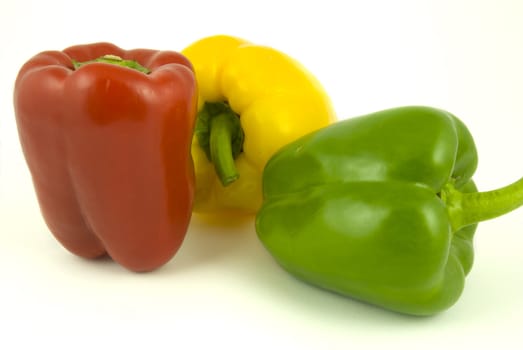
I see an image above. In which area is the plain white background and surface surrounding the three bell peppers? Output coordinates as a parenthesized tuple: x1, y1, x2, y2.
(0, 0, 523, 350)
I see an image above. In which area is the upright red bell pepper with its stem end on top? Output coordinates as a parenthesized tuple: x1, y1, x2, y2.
(14, 43, 198, 271)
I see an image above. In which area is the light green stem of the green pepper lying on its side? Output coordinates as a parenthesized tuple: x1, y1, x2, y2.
(441, 178, 523, 232)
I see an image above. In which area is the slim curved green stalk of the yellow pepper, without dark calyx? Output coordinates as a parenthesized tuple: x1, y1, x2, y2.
(210, 113, 240, 186)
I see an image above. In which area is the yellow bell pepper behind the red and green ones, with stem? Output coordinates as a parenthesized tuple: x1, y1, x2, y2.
(182, 35, 334, 216)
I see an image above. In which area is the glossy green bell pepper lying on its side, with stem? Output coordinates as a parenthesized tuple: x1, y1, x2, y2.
(256, 107, 523, 315)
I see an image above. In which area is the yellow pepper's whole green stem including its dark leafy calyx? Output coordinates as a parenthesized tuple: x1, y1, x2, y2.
(195, 102, 244, 186)
